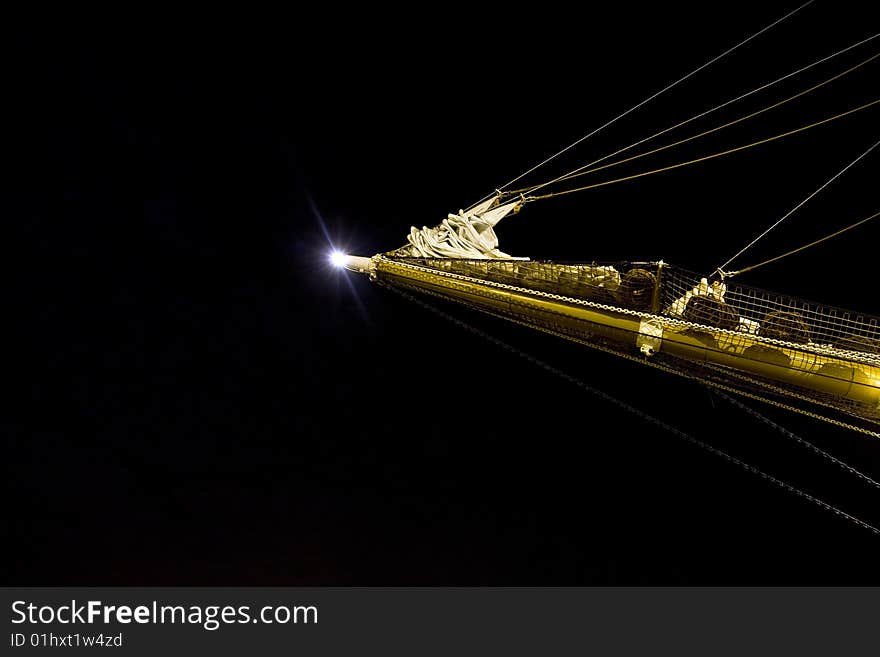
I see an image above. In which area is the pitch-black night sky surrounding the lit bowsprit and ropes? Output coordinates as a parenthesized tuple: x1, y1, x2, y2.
(12, 1, 880, 585)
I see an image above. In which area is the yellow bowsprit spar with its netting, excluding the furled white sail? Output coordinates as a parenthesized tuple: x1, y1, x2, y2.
(340, 253, 880, 433)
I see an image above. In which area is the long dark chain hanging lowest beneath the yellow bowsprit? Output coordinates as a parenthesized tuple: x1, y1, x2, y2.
(379, 281, 880, 536)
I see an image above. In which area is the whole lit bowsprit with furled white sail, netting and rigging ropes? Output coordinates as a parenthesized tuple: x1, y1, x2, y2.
(333, 2, 880, 532)
